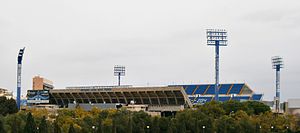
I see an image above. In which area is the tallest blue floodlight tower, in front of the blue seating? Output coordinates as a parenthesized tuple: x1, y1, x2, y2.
(206, 29, 227, 101)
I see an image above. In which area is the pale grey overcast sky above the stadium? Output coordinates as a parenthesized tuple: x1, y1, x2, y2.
(0, 0, 300, 100)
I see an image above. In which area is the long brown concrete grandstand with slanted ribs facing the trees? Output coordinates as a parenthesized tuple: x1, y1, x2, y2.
(49, 86, 192, 111)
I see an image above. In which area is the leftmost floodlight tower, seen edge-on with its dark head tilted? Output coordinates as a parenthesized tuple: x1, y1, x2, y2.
(17, 47, 25, 110)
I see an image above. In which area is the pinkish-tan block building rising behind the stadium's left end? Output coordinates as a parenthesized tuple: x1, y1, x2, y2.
(32, 76, 54, 90)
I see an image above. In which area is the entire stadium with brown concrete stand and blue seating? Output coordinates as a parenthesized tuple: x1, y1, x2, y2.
(27, 76, 263, 112)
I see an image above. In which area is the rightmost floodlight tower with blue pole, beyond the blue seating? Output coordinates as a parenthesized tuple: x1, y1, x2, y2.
(272, 56, 283, 113)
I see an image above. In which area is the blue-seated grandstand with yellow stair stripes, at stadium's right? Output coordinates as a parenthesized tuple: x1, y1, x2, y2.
(170, 83, 263, 104)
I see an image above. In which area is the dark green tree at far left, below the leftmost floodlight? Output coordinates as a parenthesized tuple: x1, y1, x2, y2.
(0, 97, 18, 116)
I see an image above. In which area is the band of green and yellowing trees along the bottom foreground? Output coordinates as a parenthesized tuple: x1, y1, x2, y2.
(0, 96, 300, 133)
